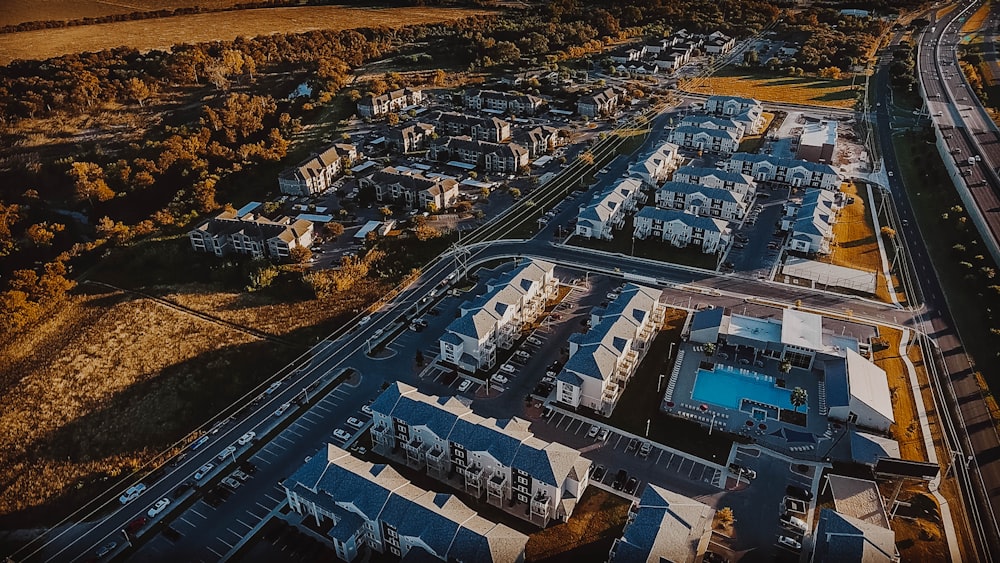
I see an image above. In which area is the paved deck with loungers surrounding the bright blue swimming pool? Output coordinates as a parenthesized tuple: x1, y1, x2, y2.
(660, 342, 850, 460)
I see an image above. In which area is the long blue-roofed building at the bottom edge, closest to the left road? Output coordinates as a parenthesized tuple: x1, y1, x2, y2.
(281, 444, 528, 563)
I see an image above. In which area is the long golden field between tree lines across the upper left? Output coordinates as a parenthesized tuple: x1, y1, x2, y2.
(0, 6, 491, 64)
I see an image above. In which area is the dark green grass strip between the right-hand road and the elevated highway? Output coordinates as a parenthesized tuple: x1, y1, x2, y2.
(894, 135, 1000, 391)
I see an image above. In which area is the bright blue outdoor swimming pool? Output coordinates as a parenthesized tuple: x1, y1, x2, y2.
(692, 365, 793, 409)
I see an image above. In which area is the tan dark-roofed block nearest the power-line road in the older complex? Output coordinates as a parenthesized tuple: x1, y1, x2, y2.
(358, 166, 459, 211)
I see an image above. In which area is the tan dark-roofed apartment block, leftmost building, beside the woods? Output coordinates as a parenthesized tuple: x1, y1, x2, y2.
(188, 211, 313, 260)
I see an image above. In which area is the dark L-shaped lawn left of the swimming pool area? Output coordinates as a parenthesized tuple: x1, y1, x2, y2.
(610, 316, 733, 460)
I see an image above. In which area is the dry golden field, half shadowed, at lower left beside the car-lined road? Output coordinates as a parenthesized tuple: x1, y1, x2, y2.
(0, 284, 283, 529)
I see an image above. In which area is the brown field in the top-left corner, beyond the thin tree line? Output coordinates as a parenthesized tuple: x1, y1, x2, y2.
(0, 0, 258, 26)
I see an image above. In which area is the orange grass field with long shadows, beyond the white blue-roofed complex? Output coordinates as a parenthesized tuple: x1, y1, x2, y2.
(680, 67, 864, 108)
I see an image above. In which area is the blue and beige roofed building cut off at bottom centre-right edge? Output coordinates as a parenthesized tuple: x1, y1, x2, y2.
(607, 483, 715, 563)
